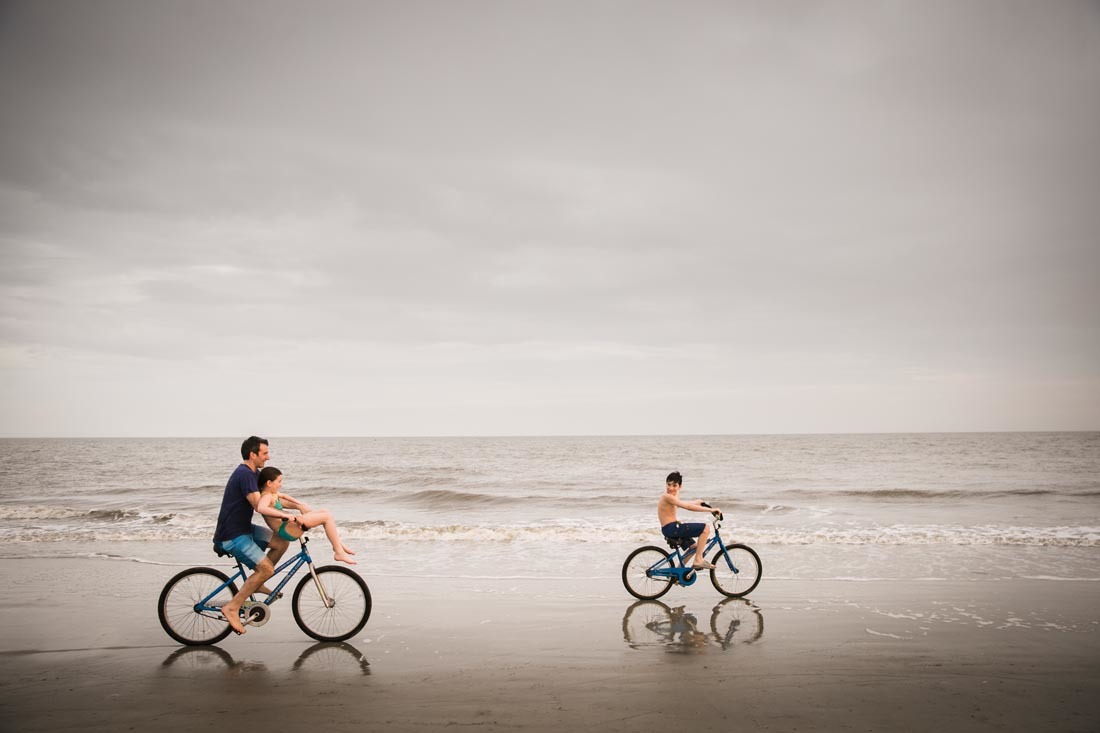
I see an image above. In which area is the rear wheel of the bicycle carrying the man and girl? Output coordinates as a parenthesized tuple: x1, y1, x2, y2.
(156, 568, 237, 646)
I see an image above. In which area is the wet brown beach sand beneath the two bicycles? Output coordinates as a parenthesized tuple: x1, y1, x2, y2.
(0, 559, 1100, 731)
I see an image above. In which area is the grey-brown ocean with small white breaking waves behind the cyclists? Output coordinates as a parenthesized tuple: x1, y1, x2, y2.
(0, 433, 1100, 590)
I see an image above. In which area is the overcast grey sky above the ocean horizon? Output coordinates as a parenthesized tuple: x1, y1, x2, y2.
(0, 0, 1100, 436)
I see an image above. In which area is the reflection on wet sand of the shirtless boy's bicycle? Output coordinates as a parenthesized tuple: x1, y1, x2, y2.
(623, 598, 763, 653)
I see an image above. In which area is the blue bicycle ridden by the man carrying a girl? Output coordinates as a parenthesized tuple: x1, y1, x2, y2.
(156, 536, 371, 646)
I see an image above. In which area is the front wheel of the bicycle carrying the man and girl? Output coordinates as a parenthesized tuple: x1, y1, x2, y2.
(292, 565, 371, 642)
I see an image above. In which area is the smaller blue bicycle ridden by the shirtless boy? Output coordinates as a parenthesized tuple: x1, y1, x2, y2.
(623, 504, 763, 601)
